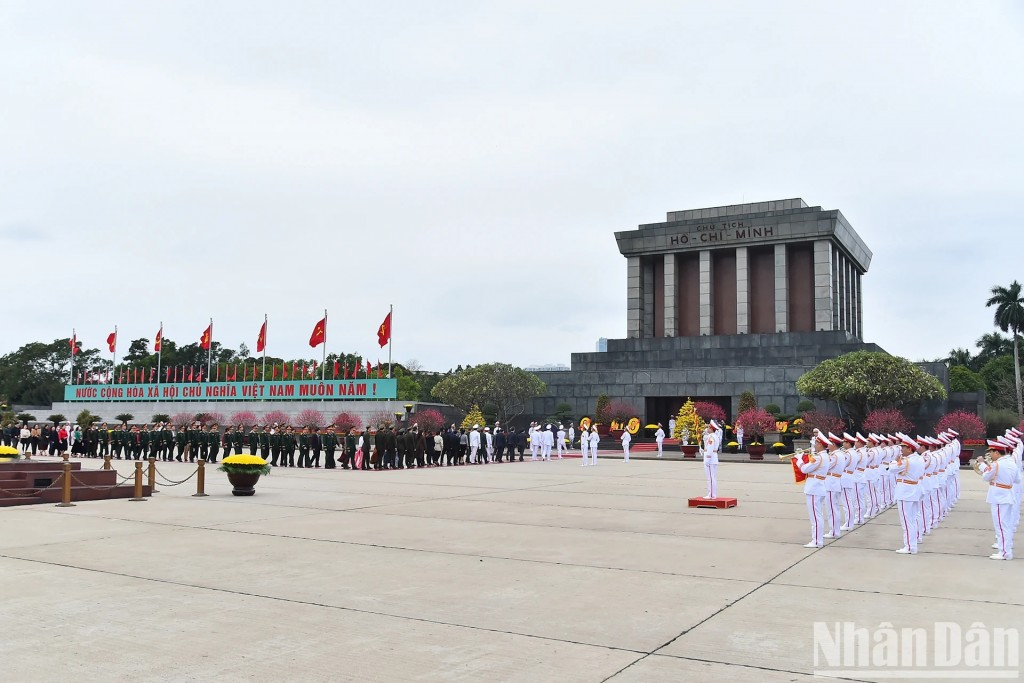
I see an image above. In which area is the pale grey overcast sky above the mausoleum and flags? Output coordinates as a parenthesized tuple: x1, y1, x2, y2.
(0, 0, 1024, 370)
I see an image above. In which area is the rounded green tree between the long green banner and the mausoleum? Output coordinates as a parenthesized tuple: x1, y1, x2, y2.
(431, 362, 547, 424)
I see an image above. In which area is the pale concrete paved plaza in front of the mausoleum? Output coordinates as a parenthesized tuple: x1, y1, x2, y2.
(0, 459, 1024, 683)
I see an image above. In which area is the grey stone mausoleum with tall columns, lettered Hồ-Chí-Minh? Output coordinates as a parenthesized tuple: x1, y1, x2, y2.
(532, 194, 947, 423)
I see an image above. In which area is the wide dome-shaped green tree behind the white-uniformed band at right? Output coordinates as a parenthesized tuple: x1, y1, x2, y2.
(797, 351, 946, 424)
